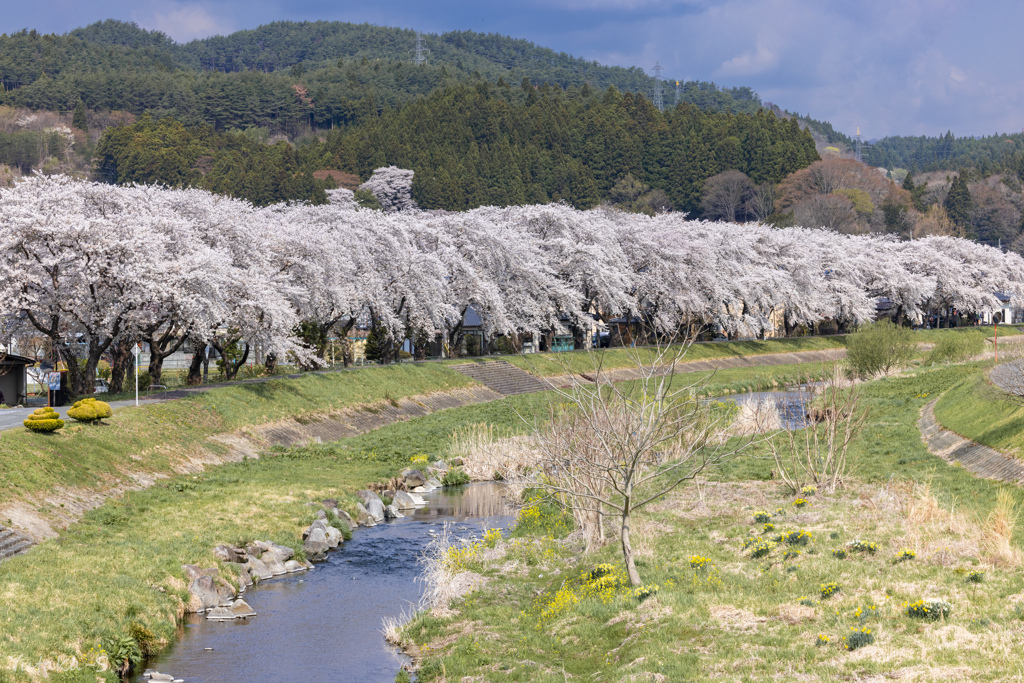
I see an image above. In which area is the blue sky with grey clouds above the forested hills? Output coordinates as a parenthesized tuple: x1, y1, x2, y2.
(0, 0, 1024, 139)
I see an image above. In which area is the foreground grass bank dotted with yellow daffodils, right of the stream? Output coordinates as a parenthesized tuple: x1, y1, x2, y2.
(403, 364, 1024, 681)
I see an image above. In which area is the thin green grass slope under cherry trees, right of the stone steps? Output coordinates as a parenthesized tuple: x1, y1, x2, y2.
(497, 337, 846, 377)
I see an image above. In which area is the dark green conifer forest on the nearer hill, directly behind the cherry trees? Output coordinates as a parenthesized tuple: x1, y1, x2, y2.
(96, 79, 818, 214)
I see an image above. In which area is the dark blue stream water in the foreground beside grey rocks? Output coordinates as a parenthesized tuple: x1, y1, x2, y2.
(138, 483, 512, 683)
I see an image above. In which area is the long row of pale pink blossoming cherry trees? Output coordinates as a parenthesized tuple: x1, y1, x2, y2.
(0, 176, 1024, 393)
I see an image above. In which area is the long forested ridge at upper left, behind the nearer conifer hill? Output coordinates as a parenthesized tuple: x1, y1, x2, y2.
(0, 19, 761, 134)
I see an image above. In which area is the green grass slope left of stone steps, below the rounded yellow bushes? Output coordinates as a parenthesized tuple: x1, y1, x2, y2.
(0, 364, 472, 507)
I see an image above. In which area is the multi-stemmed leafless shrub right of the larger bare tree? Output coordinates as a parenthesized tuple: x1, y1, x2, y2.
(768, 365, 867, 494)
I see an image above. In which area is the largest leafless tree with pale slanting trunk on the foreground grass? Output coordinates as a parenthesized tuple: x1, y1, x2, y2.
(523, 341, 754, 586)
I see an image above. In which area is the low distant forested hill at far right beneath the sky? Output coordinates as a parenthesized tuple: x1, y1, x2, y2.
(863, 132, 1024, 176)
